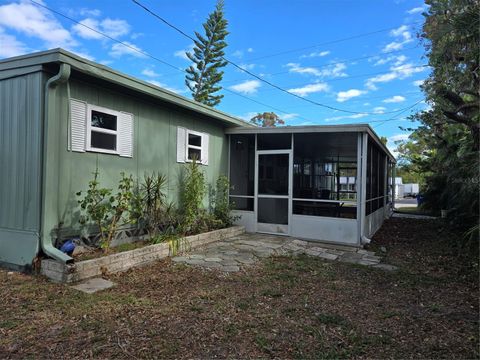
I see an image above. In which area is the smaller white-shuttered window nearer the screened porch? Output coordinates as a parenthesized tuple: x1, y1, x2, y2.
(177, 127, 209, 165)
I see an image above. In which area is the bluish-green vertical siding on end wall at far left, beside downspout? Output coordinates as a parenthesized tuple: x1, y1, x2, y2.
(0, 72, 43, 266)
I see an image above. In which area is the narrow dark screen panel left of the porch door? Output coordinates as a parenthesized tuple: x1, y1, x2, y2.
(230, 134, 255, 211)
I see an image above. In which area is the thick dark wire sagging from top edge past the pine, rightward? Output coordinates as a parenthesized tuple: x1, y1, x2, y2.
(132, 0, 424, 115)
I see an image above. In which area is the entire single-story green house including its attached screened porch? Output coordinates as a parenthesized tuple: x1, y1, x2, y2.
(0, 49, 395, 270)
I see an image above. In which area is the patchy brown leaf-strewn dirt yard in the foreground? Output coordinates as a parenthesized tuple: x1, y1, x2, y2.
(0, 219, 479, 359)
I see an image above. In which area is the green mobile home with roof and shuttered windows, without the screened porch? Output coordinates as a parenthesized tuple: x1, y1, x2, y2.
(0, 49, 248, 270)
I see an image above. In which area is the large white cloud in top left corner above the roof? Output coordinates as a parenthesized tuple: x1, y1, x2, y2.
(0, 0, 77, 48)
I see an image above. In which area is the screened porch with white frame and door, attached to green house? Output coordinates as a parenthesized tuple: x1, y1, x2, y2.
(229, 126, 394, 246)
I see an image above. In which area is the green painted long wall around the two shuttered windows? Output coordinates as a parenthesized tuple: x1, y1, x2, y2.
(43, 76, 228, 245)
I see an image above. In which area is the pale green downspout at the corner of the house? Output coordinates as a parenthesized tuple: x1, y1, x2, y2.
(40, 63, 73, 264)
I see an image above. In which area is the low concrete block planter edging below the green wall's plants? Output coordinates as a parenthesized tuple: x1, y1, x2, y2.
(40, 226, 245, 283)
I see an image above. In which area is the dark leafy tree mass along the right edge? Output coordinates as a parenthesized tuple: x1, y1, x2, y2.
(400, 0, 480, 250)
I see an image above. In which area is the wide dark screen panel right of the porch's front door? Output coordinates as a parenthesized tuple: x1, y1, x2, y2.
(293, 133, 357, 219)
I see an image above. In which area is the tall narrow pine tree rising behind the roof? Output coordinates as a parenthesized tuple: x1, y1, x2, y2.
(185, 0, 228, 107)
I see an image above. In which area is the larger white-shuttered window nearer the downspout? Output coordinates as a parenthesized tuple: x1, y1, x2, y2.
(69, 99, 133, 157)
